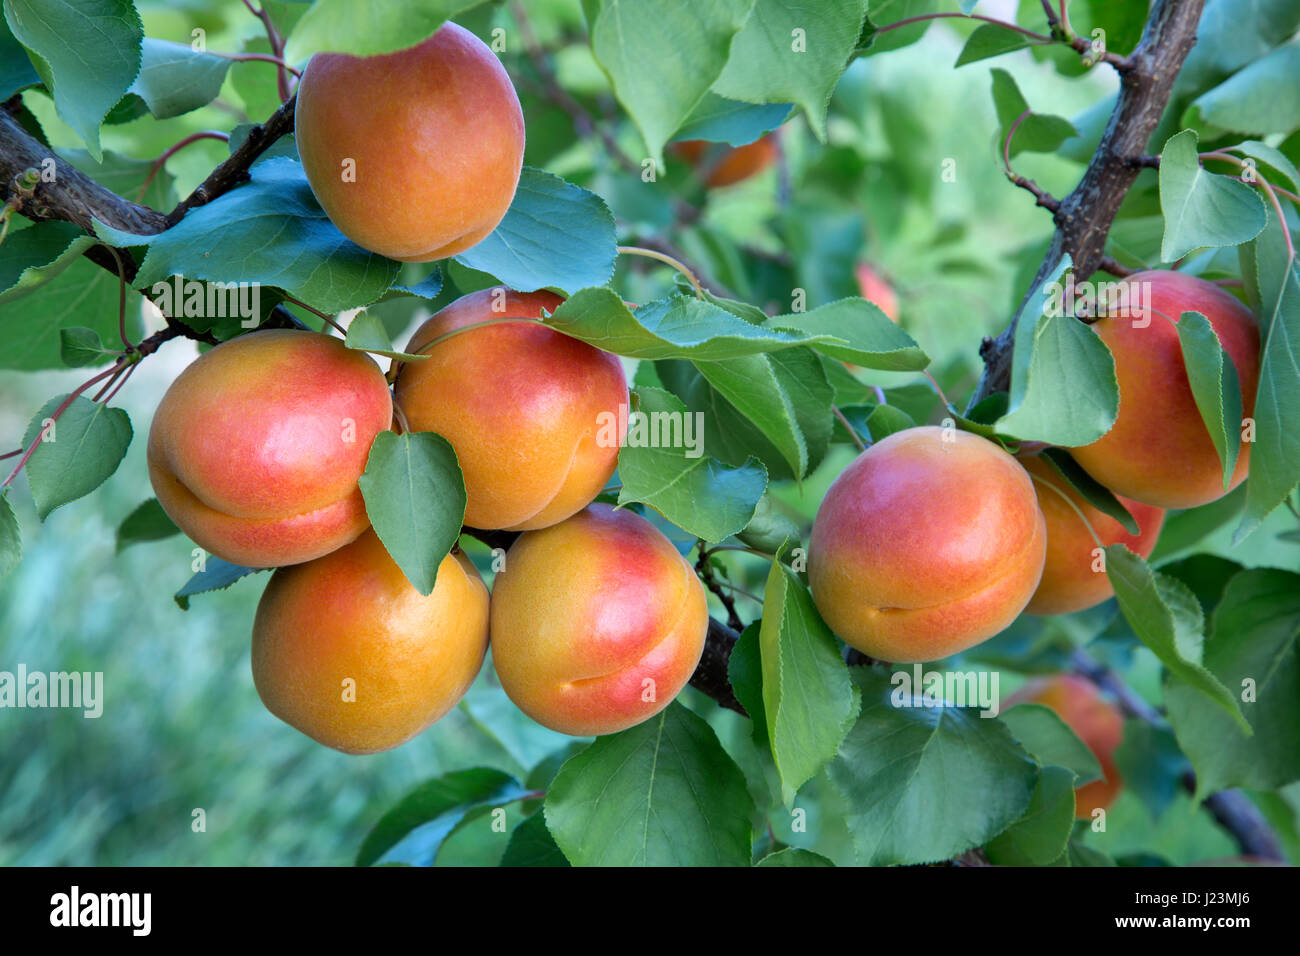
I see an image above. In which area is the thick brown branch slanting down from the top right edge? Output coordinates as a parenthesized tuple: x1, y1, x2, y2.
(971, 0, 1205, 407)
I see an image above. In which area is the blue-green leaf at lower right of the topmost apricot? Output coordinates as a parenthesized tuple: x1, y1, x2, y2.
(455, 166, 618, 293)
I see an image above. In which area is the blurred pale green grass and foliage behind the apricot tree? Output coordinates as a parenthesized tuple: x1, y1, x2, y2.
(0, 0, 1300, 865)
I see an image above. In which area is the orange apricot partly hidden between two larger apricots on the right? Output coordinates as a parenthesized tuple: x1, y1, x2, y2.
(1019, 455, 1165, 614)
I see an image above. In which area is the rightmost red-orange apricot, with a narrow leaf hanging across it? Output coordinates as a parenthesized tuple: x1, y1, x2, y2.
(1073, 271, 1260, 509)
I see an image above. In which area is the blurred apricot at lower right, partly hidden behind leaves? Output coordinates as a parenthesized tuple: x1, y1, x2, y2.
(1002, 674, 1125, 819)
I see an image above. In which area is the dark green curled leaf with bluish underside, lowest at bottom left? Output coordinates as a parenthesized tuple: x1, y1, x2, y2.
(356, 767, 528, 866)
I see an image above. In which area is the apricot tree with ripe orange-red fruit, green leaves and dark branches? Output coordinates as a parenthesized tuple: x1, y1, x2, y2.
(0, 0, 1300, 865)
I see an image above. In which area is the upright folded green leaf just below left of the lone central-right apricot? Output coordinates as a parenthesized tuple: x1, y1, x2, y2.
(759, 562, 859, 806)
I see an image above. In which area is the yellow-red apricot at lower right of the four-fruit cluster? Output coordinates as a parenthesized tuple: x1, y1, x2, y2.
(491, 505, 709, 736)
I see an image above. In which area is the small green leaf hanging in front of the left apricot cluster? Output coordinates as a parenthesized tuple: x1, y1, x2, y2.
(359, 432, 465, 594)
